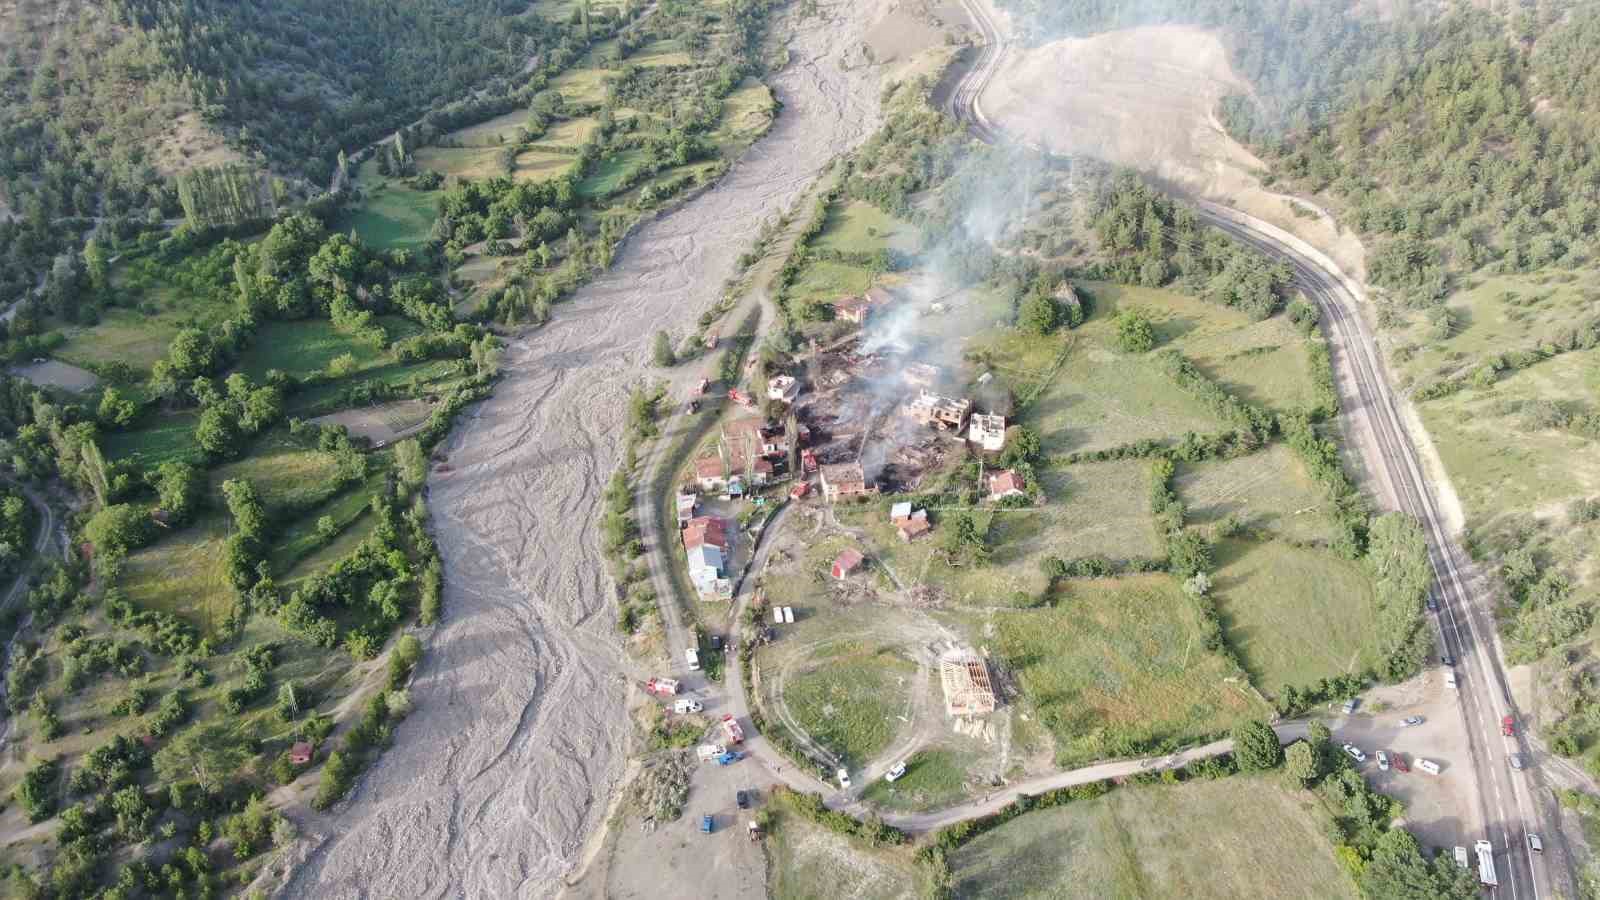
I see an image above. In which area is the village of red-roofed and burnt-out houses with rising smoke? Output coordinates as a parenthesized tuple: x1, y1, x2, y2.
(677, 287, 1011, 729)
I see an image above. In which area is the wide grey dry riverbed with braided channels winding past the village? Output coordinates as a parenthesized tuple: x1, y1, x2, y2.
(282, 2, 880, 897)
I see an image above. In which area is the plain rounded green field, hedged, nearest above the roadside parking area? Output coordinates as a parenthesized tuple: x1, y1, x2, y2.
(1211, 540, 1379, 693)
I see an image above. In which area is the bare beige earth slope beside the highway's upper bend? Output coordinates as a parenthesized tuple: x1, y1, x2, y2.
(981, 26, 1366, 279)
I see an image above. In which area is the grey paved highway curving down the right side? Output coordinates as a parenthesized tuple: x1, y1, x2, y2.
(950, 0, 1566, 900)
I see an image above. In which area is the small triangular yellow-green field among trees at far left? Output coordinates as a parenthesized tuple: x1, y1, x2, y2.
(120, 511, 234, 633)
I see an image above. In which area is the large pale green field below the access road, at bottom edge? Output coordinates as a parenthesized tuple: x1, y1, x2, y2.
(950, 775, 1357, 900)
